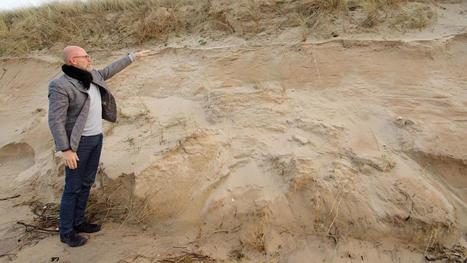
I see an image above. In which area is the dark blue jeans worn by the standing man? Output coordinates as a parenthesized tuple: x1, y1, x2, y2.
(60, 134, 103, 235)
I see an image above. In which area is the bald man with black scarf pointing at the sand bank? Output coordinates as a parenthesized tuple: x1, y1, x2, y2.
(48, 46, 149, 247)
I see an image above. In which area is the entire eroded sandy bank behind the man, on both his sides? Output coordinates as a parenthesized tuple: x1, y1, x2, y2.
(0, 31, 467, 262)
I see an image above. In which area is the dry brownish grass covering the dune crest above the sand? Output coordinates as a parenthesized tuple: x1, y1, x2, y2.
(0, 0, 435, 55)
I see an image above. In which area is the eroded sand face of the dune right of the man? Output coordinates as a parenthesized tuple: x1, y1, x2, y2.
(99, 34, 467, 244)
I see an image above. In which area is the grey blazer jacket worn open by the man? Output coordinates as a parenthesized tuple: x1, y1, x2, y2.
(48, 56, 132, 151)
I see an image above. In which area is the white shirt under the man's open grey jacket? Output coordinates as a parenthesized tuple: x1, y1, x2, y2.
(82, 83, 102, 136)
